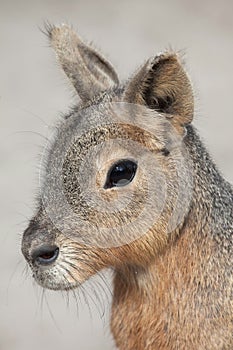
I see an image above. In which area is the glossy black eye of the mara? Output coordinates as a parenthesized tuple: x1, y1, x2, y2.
(104, 160, 137, 188)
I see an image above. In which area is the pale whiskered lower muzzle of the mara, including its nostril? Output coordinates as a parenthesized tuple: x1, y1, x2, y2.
(23, 238, 102, 291)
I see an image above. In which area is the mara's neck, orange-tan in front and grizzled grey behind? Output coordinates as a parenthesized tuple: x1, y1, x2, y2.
(111, 127, 233, 350)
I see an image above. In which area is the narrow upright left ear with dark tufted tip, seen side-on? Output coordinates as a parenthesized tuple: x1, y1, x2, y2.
(48, 25, 119, 101)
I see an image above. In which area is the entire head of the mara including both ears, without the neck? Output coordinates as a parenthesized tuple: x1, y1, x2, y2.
(22, 26, 193, 290)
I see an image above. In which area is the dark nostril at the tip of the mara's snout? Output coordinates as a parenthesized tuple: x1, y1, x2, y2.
(31, 245, 59, 265)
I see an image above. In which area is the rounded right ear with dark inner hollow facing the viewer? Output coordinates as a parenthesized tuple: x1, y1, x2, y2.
(124, 53, 194, 128)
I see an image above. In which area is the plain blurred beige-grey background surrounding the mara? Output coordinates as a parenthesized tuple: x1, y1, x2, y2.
(0, 0, 233, 350)
